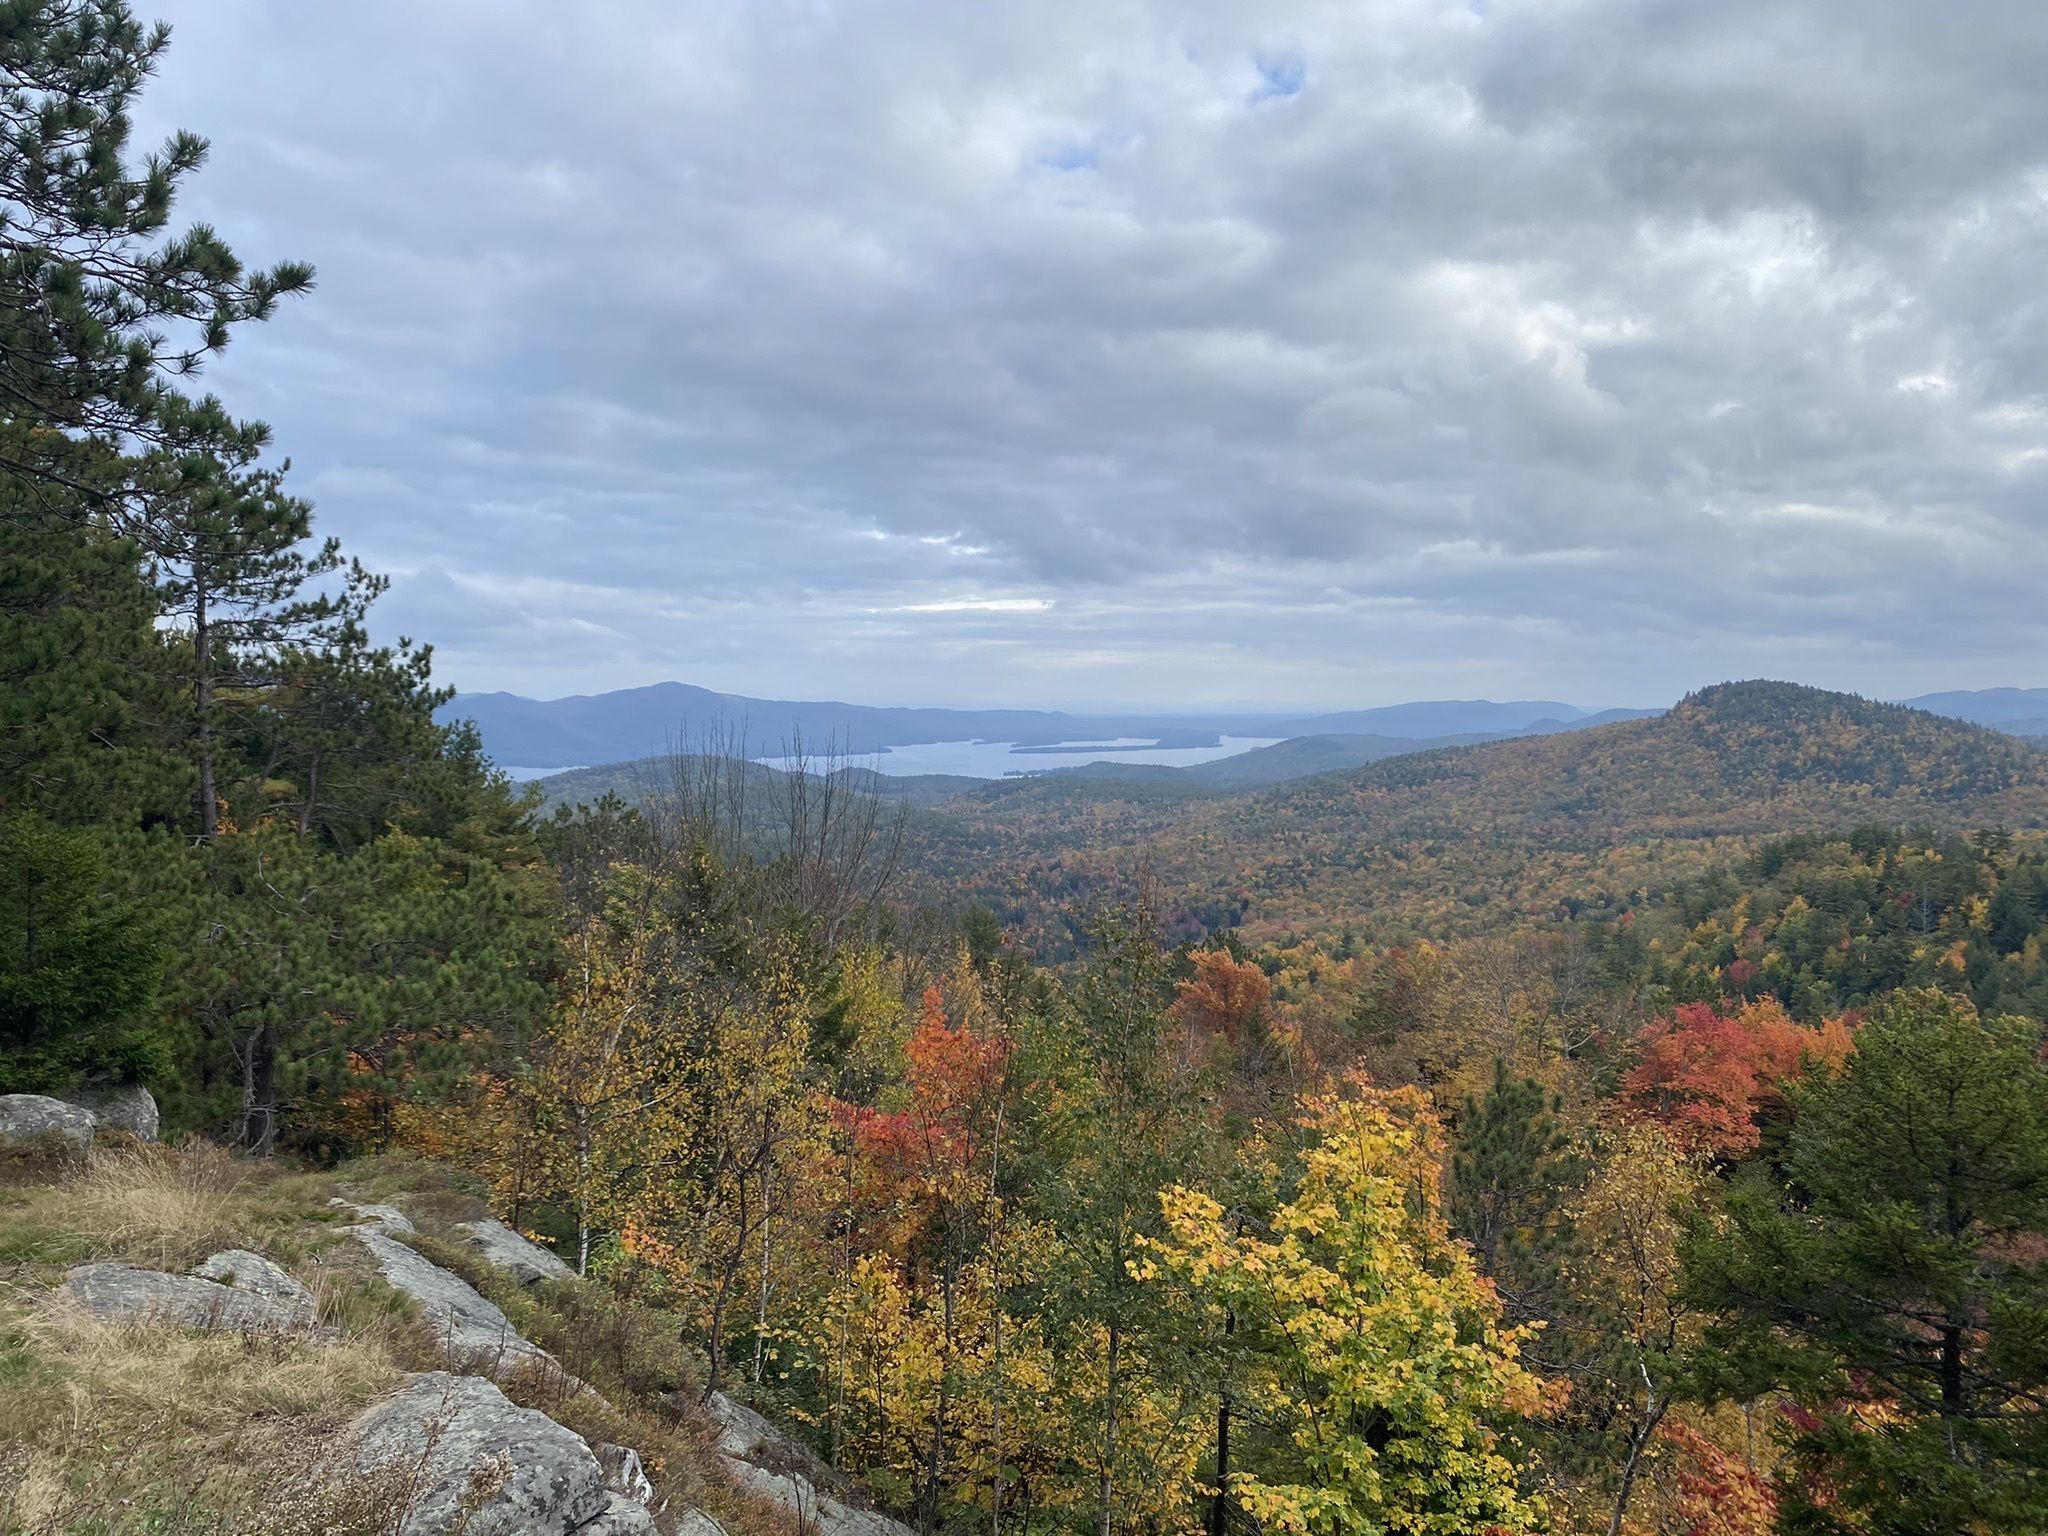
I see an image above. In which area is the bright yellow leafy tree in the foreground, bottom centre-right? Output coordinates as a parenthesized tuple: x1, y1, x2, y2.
(1139, 1081, 1540, 1536)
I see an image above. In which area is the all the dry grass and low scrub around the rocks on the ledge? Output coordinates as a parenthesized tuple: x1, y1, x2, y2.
(0, 1145, 827, 1536)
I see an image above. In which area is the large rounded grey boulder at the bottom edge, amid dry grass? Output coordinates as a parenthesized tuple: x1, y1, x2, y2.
(336, 1370, 655, 1536)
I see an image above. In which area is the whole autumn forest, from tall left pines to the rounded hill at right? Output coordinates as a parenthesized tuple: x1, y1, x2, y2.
(0, 0, 2048, 1536)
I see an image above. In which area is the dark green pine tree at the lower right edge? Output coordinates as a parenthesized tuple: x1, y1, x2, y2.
(1688, 991, 2048, 1536)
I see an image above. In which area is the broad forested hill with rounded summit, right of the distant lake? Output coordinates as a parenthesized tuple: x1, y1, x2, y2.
(915, 682, 2048, 946)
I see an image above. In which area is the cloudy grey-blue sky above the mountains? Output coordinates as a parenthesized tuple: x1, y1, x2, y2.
(137, 0, 2048, 709)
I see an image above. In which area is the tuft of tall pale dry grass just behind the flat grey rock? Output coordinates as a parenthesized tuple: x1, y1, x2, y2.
(63, 1145, 250, 1270)
